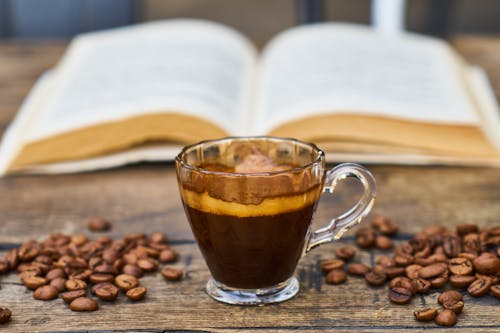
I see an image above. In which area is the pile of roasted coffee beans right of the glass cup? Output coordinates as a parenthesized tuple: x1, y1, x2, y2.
(320, 217, 500, 326)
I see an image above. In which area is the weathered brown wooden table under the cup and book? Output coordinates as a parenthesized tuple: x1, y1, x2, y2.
(0, 37, 500, 332)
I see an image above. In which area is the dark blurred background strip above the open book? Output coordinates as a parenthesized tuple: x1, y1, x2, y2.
(0, 0, 500, 44)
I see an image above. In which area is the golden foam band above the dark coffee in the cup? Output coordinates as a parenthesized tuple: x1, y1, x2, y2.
(182, 186, 320, 217)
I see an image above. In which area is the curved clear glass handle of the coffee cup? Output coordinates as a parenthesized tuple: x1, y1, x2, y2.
(305, 163, 377, 252)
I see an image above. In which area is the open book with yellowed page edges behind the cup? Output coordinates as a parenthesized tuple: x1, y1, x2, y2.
(0, 20, 500, 173)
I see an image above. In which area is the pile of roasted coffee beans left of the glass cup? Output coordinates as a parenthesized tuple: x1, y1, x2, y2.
(0, 218, 183, 316)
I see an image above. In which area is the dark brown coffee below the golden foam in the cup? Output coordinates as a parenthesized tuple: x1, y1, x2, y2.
(184, 205, 314, 289)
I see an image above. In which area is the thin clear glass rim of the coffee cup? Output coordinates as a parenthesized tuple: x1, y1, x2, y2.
(175, 135, 325, 177)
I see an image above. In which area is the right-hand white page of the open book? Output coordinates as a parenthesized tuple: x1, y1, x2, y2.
(255, 23, 478, 134)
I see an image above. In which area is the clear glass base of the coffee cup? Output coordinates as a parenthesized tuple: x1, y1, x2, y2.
(206, 277, 299, 305)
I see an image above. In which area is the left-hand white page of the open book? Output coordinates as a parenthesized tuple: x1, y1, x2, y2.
(25, 20, 256, 142)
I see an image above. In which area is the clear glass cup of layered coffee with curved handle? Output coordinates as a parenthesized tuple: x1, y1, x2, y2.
(175, 137, 376, 305)
